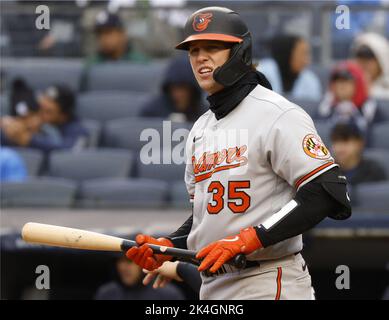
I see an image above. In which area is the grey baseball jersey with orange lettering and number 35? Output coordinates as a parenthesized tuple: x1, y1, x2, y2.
(185, 85, 336, 260)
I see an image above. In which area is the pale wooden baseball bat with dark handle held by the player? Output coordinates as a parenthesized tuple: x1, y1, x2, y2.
(22, 222, 246, 269)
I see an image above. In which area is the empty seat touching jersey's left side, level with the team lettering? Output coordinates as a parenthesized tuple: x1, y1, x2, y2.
(137, 154, 185, 182)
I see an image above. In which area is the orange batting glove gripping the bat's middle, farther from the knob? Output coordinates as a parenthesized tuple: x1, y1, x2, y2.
(126, 234, 174, 271)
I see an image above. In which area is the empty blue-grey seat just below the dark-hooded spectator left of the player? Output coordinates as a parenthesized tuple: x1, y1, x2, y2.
(103, 118, 192, 150)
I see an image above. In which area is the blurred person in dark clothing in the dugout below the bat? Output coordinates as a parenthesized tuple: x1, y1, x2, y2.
(95, 257, 184, 300)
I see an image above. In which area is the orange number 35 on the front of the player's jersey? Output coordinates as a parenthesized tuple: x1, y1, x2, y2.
(207, 181, 251, 214)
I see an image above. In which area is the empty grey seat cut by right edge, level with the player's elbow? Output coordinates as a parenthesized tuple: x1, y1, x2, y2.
(356, 182, 389, 213)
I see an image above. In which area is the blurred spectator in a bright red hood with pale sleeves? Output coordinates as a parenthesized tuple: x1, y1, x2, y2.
(318, 61, 377, 134)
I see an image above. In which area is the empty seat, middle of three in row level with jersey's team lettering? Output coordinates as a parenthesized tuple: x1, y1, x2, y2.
(49, 149, 133, 182)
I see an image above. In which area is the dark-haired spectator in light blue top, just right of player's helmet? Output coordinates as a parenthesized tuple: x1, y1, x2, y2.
(257, 35, 322, 100)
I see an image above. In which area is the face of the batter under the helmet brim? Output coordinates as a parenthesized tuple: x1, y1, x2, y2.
(189, 40, 231, 95)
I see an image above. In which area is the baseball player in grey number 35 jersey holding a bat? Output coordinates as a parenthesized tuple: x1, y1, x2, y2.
(127, 7, 351, 299)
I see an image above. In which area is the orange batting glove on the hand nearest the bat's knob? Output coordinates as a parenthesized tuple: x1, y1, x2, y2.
(196, 227, 262, 272)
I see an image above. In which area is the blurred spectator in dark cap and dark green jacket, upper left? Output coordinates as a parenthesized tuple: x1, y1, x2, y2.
(87, 11, 148, 65)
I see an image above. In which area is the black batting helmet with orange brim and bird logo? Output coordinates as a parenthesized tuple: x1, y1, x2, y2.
(176, 7, 252, 86)
